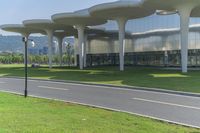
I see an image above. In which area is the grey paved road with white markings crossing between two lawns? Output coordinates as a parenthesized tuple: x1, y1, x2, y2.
(0, 78, 200, 128)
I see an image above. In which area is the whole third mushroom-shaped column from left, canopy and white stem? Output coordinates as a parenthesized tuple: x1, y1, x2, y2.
(52, 9, 106, 69)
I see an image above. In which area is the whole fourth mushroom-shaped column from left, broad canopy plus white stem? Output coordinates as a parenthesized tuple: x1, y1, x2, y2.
(89, 0, 155, 71)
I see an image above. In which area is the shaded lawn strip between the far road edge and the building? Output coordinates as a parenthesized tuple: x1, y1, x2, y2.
(0, 65, 200, 93)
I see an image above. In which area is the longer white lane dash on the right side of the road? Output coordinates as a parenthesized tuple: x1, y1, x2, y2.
(132, 98, 200, 110)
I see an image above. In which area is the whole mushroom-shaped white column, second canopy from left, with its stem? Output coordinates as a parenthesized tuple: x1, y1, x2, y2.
(23, 19, 72, 68)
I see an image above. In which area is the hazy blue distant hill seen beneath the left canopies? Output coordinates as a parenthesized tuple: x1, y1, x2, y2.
(0, 35, 74, 53)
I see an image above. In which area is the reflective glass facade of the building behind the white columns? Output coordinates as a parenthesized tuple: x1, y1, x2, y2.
(75, 14, 200, 66)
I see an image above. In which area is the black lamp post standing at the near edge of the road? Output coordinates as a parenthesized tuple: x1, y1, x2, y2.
(22, 37, 33, 98)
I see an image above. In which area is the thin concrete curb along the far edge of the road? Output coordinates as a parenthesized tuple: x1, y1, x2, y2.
(0, 76, 200, 97)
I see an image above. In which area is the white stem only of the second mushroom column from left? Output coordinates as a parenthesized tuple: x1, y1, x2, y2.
(46, 30, 53, 68)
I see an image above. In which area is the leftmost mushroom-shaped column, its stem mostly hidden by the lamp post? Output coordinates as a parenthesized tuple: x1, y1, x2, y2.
(0, 24, 45, 63)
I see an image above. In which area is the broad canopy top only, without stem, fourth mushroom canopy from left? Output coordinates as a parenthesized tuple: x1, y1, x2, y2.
(89, 0, 155, 20)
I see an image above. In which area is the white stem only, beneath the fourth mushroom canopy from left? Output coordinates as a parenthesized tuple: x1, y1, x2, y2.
(117, 18, 127, 71)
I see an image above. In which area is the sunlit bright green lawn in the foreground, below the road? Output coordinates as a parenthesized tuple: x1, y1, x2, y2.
(0, 93, 200, 133)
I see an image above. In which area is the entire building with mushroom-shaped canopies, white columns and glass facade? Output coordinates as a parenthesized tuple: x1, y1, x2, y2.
(1, 0, 200, 73)
